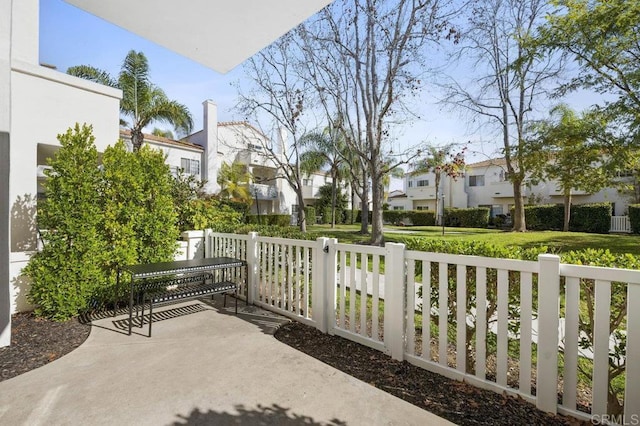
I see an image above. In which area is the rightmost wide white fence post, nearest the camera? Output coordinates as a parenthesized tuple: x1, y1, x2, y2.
(536, 254, 560, 414)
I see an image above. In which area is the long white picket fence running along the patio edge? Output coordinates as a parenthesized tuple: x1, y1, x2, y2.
(198, 231, 640, 420)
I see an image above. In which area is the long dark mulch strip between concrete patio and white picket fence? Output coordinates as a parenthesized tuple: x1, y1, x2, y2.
(275, 322, 589, 425)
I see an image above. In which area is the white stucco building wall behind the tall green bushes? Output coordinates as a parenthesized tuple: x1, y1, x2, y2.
(9, 60, 121, 313)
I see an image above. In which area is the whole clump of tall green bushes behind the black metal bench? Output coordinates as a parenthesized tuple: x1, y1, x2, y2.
(25, 125, 178, 320)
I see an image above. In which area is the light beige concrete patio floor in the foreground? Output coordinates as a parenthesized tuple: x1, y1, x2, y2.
(0, 299, 451, 425)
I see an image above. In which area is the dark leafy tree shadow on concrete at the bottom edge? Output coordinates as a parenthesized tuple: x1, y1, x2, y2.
(171, 404, 347, 426)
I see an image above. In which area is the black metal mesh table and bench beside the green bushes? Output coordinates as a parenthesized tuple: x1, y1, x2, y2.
(118, 257, 247, 337)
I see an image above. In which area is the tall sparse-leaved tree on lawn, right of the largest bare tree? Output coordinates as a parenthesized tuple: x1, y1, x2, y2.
(444, 0, 564, 231)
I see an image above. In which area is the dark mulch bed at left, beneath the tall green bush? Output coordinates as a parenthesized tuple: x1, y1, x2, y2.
(0, 312, 91, 382)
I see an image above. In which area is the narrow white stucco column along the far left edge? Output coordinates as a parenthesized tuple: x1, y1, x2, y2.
(0, 0, 12, 347)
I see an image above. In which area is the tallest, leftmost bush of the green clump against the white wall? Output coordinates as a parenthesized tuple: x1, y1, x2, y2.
(24, 125, 108, 321)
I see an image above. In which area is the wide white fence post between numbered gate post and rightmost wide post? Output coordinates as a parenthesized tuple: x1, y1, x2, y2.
(384, 243, 406, 361)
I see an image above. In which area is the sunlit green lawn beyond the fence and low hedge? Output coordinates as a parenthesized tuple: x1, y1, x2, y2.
(309, 225, 640, 256)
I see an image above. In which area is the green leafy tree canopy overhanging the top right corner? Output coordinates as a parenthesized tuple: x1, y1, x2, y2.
(539, 0, 640, 133)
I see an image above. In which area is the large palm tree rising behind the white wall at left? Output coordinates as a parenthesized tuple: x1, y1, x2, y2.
(67, 50, 193, 151)
